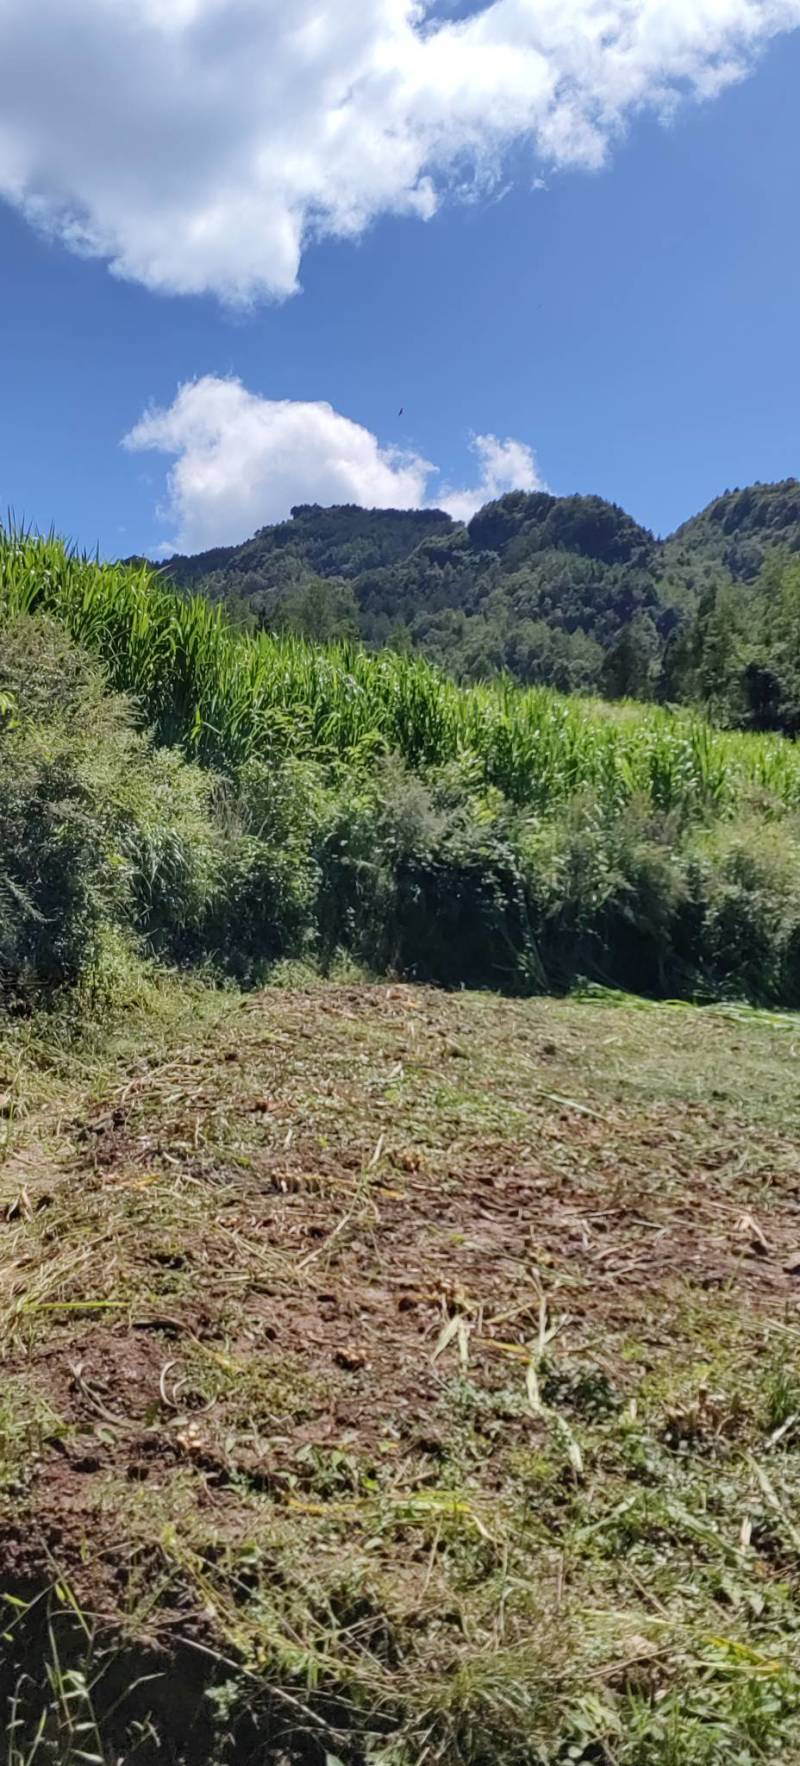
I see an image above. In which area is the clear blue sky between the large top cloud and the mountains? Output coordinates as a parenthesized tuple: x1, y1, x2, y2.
(0, 7, 800, 555)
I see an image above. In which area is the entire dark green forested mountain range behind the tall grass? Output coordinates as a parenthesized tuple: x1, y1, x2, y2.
(157, 479, 800, 733)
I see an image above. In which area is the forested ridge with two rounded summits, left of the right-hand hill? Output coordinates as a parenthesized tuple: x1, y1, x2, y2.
(157, 491, 673, 691)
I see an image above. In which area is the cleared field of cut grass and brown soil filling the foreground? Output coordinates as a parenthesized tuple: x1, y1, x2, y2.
(0, 982, 800, 1766)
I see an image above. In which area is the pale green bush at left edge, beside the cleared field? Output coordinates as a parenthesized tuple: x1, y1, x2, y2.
(0, 616, 221, 1001)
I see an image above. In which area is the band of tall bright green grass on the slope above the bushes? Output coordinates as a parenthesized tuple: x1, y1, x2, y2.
(0, 532, 800, 816)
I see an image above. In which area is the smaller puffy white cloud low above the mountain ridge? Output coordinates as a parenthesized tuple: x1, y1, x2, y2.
(124, 374, 540, 551)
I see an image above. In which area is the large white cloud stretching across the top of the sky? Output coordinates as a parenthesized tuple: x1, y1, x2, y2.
(0, 0, 800, 300)
